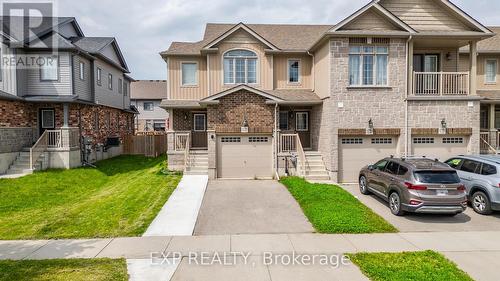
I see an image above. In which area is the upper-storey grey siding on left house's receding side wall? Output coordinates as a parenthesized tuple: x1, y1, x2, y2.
(94, 60, 130, 109)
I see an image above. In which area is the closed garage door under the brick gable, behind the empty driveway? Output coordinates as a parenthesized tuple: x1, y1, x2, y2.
(217, 136, 273, 179)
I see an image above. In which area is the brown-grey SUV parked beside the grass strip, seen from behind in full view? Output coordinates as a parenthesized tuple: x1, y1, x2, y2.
(359, 158, 467, 216)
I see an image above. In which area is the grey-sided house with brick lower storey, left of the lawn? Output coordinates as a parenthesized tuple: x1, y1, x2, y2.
(0, 16, 137, 174)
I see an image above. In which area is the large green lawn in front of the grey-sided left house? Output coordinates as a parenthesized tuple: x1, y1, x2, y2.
(0, 156, 181, 240)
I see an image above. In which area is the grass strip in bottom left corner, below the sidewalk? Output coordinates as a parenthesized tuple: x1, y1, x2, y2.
(0, 259, 128, 281)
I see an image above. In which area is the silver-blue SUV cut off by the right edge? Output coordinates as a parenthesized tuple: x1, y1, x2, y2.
(446, 155, 500, 215)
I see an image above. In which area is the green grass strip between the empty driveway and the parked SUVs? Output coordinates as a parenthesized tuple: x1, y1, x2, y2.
(281, 177, 397, 233)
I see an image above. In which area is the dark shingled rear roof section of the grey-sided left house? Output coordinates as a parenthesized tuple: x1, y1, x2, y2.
(73, 37, 129, 72)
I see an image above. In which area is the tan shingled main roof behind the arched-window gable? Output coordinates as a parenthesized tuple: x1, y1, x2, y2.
(161, 23, 333, 55)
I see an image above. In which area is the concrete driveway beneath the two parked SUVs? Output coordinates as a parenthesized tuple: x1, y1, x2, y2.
(343, 185, 500, 232)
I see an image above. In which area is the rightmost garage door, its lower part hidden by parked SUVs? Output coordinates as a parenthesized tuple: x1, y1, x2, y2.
(412, 135, 469, 161)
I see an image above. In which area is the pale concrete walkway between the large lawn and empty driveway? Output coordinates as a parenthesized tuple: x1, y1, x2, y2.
(143, 175, 208, 236)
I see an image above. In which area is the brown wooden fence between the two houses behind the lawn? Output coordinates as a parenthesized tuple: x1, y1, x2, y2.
(123, 134, 167, 157)
